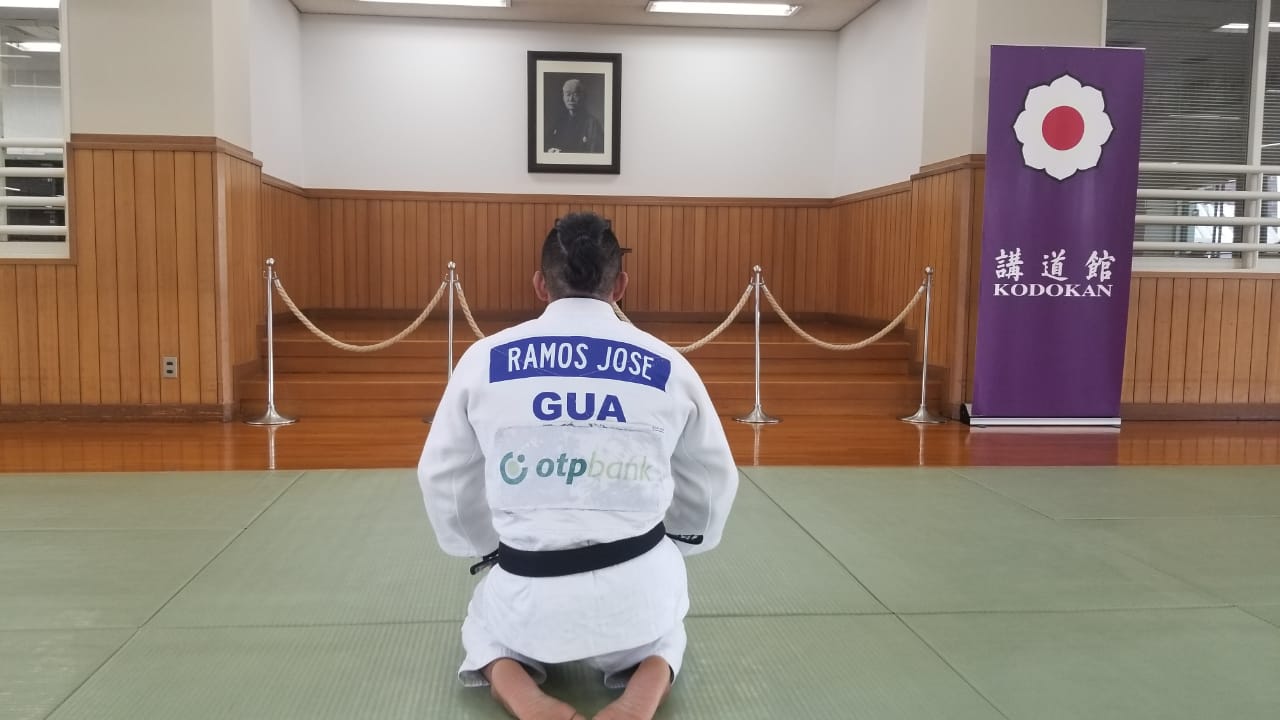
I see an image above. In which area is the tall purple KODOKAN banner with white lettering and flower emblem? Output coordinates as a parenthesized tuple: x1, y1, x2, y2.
(973, 46, 1143, 418)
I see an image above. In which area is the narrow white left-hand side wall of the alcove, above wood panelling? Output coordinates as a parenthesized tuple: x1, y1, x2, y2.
(250, 0, 306, 186)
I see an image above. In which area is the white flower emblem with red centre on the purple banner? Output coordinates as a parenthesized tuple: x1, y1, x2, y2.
(1014, 74, 1114, 181)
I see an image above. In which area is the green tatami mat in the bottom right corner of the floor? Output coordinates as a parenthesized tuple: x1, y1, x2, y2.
(905, 609, 1280, 720)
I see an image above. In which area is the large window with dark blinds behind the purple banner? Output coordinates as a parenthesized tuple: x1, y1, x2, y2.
(1107, 0, 1280, 269)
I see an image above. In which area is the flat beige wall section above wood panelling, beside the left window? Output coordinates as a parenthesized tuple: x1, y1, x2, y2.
(67, 0, 215, 136)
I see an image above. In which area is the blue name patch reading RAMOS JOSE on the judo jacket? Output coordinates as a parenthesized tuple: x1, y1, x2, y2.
(489, 336, 671, 391)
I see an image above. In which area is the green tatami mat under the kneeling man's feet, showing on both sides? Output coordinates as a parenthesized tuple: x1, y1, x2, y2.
(52, 616, 1000, 720)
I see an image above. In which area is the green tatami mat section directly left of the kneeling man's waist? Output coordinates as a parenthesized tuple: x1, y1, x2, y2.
(155, 470, 476, 626)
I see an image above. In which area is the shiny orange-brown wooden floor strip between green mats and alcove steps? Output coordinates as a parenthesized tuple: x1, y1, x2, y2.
(0, 412, 1280, 473)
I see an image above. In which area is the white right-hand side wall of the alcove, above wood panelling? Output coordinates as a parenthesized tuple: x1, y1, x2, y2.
(832, 0, 928, 196)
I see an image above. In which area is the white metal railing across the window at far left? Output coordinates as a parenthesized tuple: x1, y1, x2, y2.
(0, 137, 68, 258)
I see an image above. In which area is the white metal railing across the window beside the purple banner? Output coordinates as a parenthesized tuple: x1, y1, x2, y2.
(1133, 163, 1280, 269)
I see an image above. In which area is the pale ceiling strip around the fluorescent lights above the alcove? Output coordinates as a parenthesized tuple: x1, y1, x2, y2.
(292, 0, 876, 31)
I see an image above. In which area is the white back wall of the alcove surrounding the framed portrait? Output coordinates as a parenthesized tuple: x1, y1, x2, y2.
(302, 15, 837, 197)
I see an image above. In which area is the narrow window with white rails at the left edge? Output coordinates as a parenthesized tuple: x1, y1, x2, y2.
(0, 3, 70, 259)
